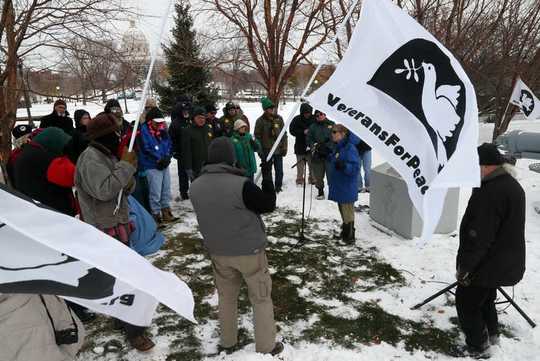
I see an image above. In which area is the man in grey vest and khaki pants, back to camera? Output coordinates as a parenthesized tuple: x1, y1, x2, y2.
(190, 137, 283, 355)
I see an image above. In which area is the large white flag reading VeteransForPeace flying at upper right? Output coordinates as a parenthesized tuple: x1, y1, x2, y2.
(308, 0, 480, 240)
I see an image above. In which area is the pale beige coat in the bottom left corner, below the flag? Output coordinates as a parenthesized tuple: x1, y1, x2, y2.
(0, 294, 85, 361)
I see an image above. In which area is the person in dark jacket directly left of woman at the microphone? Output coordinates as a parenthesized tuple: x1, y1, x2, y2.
(307, 110, 334, 200)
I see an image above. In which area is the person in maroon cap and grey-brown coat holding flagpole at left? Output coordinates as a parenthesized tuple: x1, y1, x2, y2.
(75, 113, 154, 352)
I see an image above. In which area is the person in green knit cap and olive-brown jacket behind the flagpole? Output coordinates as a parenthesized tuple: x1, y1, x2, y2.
(255, 97, 288, 193)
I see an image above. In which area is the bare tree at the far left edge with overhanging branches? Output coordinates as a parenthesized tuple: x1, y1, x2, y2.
(0, 0, 126, 161)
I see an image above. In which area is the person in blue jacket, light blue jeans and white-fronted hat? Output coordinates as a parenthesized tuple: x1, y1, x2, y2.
(138, 108, 178, 225)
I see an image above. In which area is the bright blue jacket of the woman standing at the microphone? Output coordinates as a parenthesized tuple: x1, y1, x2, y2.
(328, 133, 360, 203)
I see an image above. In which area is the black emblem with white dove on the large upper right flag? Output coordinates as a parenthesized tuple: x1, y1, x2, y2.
(368, 39, 467, 172)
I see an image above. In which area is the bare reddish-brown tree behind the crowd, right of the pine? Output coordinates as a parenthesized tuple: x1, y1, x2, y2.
(201, 0, 331, 104)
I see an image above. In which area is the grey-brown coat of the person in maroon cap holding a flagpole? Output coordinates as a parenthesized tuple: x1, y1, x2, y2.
(75, 142, 136, 229)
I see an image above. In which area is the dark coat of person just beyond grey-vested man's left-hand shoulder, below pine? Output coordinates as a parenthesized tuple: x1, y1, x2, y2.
(182, 124, 213, 175)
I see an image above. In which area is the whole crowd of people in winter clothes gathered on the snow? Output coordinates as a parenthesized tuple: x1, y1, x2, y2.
(0, 94, 525, 360)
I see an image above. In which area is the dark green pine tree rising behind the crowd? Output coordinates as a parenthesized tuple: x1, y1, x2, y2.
(156, 0, 217, 112)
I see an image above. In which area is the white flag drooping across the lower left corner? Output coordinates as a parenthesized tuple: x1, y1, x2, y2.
(0, 185, 195, 326)
